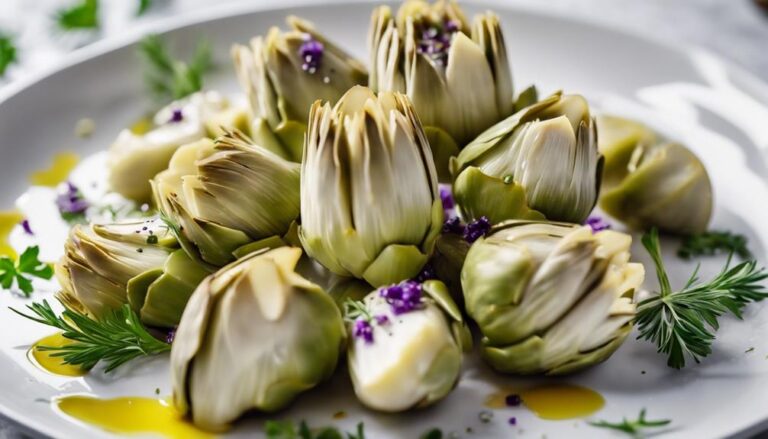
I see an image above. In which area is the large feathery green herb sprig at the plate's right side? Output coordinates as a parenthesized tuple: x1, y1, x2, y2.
(635, 229, 768, 369)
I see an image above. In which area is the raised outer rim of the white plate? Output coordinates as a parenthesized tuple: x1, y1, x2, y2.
(0, 0, 768, 438)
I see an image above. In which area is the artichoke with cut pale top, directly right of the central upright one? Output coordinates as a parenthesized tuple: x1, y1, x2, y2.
(451, 92, 603, 224)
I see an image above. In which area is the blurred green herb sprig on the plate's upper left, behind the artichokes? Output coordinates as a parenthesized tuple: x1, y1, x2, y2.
(139, 35, 212, 102)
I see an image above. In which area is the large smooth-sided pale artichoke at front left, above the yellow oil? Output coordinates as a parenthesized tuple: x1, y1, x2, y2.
(171, 247, 345, 430)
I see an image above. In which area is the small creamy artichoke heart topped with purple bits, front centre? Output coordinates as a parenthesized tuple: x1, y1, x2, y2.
(346, 281, 464, 412)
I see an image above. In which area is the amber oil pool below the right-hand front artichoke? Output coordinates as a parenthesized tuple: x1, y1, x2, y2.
(520, 384, 605, 420)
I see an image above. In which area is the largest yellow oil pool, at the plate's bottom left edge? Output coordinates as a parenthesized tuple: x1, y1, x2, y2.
(56, 396, 214, 439)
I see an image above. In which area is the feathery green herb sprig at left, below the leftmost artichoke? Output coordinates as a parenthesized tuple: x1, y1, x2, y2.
(11, 300, 171, 372)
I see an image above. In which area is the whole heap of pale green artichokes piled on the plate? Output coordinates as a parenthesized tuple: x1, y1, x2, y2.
(56, 0, 711, 430)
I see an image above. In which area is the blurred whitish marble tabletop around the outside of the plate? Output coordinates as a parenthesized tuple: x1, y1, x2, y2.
(0, 0, 768, 439)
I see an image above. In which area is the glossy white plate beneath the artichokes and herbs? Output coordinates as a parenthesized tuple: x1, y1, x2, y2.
(0, 0, 768, 438)
